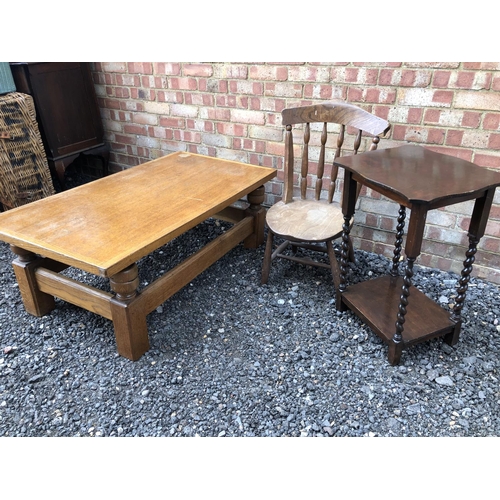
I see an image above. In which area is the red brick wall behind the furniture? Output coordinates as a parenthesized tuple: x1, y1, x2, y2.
(94, 62, 500, 283)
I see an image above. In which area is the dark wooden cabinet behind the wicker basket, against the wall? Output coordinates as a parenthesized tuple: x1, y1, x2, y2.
(10, 62, 109, 188)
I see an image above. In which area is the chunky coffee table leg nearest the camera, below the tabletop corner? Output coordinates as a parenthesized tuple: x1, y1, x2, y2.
(110, 264, 149, 361)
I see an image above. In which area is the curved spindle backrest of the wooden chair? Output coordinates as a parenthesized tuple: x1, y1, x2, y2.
(281, 101, 391, 203)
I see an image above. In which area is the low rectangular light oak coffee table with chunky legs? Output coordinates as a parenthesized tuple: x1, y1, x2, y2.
(0, 152, 276, 360)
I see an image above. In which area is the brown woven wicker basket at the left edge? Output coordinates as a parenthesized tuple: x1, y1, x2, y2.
(0, 92, 55, 209)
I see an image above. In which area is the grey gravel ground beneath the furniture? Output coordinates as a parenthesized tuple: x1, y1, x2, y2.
(0, 172, 500, 437)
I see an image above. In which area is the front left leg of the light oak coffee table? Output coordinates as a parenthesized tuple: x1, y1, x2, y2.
(10, 245, 55, 316)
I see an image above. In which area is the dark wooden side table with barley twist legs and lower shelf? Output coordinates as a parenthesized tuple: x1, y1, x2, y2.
(335, 145, 500, 365)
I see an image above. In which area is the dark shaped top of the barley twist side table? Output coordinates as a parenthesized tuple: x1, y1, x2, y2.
(335, 145, 500, 209)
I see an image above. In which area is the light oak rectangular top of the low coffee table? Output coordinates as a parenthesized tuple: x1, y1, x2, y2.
(0, 152, 276, 277)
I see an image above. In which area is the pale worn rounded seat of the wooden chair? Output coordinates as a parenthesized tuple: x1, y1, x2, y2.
(266, 198, 344, 242)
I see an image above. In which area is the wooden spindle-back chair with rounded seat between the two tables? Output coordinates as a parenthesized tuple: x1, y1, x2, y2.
(262, 101, 391, 289)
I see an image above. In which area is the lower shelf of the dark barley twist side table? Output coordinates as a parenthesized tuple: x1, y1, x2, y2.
(342, 276, 456, 345)
